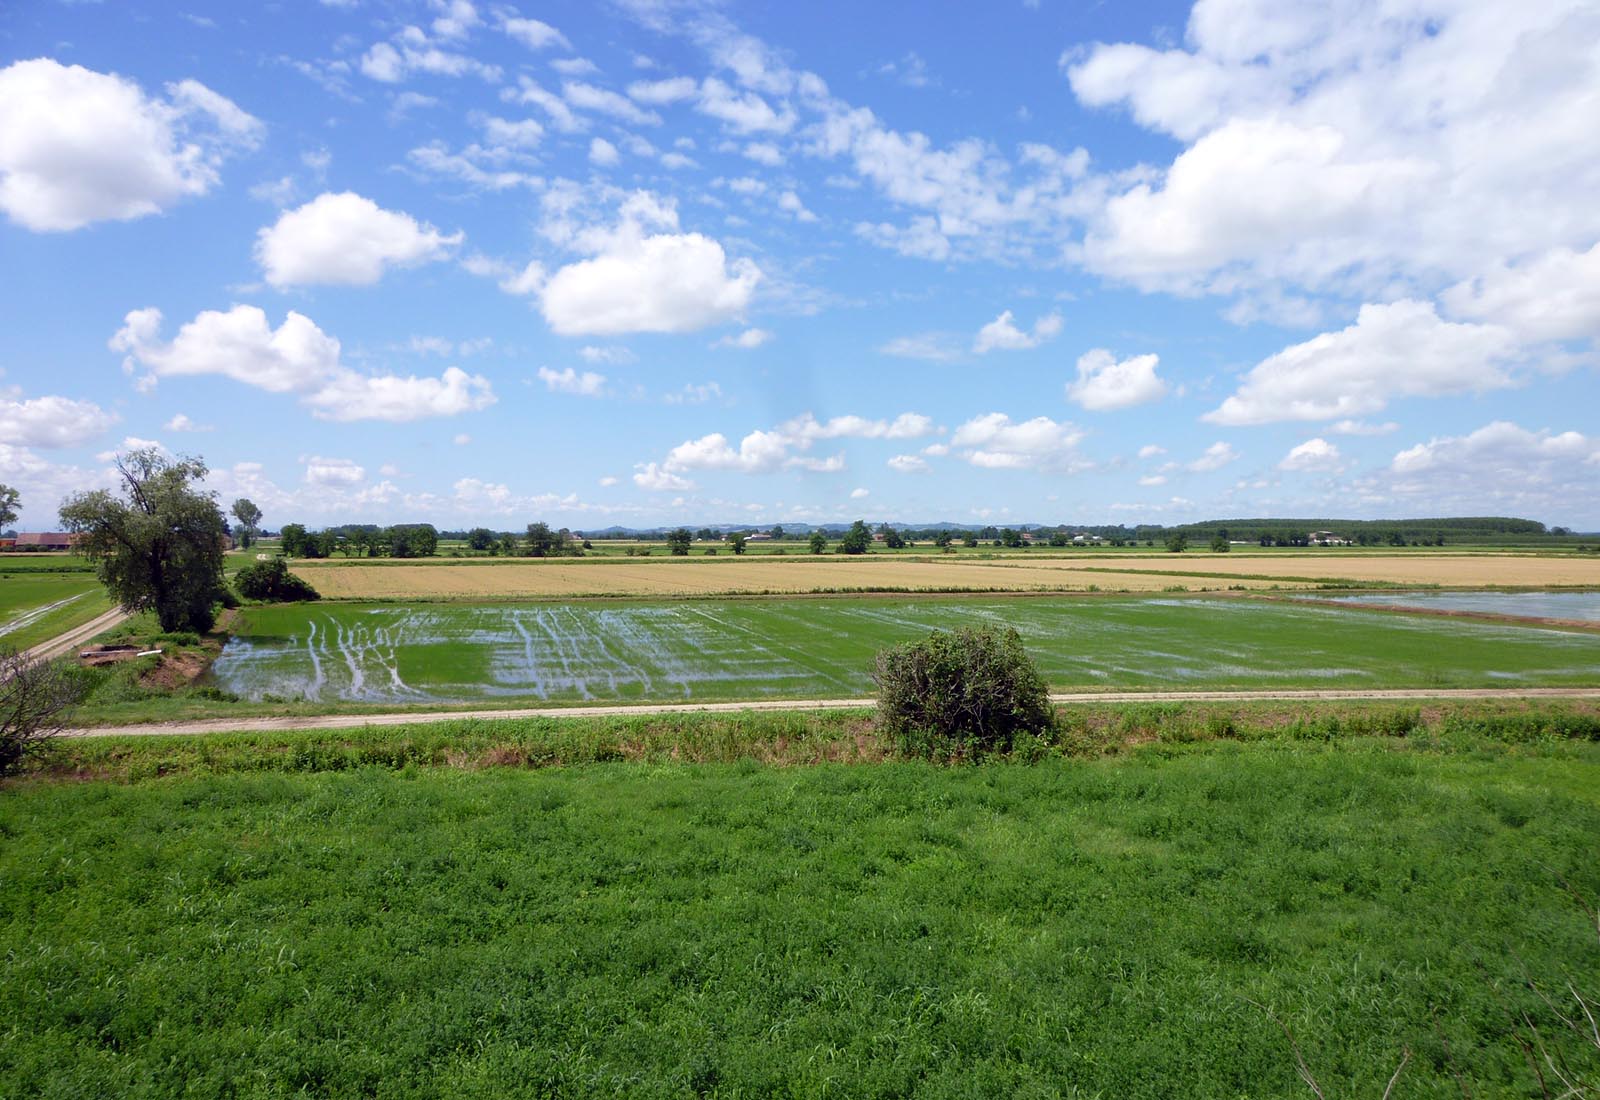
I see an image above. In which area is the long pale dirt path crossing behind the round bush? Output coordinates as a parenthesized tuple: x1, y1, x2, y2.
(61, 688, 1600, 737)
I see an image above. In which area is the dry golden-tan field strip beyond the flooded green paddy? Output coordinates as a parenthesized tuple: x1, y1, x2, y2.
(294, 550, 1600, 600)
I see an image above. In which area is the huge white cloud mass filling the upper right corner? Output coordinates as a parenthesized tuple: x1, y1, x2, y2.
(1062, 0, 1600, 300)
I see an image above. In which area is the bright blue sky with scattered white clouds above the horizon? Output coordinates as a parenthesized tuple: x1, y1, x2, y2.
(0, 0, 1600, 531)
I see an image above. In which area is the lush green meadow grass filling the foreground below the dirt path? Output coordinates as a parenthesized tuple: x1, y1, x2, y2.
(0, 740, 1600, 1098)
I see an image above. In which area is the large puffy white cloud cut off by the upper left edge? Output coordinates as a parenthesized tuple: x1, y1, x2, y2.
(0, 58, 264, 232)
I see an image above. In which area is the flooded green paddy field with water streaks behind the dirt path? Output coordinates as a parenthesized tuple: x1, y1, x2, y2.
(200, 596, 1600, 705)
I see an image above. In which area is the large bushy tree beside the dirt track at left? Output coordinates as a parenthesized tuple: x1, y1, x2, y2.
(61, 448, 227, 630)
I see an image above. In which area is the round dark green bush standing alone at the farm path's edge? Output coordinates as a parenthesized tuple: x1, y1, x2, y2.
(872, 627, 1054, 758)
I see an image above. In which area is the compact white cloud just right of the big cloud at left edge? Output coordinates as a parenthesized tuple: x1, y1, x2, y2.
(256, 192, 466, 288)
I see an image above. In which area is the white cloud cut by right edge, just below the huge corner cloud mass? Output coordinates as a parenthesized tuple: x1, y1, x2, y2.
(1440, 245, 1600, 341)
